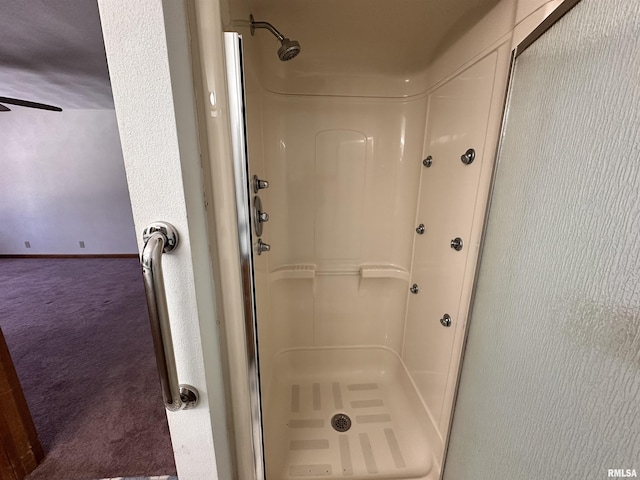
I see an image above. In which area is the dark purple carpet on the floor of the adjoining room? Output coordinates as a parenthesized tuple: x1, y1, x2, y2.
(0, 258, 176, 480)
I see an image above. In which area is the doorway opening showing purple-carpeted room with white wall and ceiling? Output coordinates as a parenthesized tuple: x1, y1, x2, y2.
(0, 2, 175, 480)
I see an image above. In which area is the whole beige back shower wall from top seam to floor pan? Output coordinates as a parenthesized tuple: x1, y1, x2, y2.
(259, 92, 427, 390)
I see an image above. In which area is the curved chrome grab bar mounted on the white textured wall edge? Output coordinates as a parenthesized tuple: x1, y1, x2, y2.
(141, 222, 199, 412)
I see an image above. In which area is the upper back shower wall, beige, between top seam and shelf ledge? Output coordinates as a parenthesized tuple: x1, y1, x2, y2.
(263, 94, 426, 270)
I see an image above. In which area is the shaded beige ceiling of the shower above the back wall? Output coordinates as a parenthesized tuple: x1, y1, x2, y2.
(251, 0, 498, 75)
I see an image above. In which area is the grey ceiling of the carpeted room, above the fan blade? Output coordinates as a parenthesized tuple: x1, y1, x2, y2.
(0, 0, 113, 110)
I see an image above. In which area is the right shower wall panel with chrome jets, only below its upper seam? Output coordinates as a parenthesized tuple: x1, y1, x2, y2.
(402, 44, 509, 438)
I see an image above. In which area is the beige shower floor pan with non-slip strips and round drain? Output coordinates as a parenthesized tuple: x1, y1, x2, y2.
(263, 347, 437, 480)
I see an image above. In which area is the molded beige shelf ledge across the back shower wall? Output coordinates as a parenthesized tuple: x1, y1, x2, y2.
(269, 264, 409, 282)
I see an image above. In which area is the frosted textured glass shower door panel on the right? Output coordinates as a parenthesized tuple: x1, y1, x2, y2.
(444, 0, 640, 480)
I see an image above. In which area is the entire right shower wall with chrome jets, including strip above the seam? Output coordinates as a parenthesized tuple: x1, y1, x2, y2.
(402, 0, 561, 449)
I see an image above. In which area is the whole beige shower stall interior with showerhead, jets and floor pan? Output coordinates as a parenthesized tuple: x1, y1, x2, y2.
(196, 0, 557, 480)
